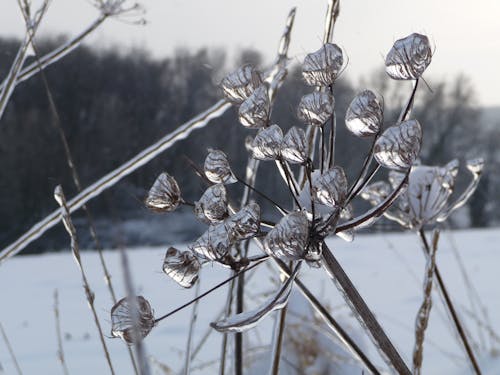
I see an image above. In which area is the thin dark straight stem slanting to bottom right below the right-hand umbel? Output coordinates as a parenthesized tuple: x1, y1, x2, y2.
(418, 229, 481, 375)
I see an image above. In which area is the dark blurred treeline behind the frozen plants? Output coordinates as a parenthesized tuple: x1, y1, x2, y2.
(0, 39, 498, 252)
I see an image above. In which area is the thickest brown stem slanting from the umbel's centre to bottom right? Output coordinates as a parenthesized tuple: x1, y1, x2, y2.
(322, 243, 411, 375)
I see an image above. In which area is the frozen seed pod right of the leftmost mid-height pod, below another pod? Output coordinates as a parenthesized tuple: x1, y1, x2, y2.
(194, 184, 227, 224)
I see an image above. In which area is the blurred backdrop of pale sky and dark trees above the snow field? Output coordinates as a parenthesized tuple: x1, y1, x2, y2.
(0, 0, 500, 253)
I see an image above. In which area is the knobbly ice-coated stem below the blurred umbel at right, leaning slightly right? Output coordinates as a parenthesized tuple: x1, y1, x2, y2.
(413, 231, 439, 375)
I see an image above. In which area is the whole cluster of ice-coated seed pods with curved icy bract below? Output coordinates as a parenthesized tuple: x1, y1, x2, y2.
(111, 34, 432, 343)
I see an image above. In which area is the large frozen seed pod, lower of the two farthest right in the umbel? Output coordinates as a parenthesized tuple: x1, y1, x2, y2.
(373, 120, 422, 169)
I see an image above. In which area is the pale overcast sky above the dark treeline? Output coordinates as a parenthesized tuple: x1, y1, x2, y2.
(0, 0, 500, 106)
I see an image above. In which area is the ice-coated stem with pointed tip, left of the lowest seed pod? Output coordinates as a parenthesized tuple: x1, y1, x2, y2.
(54, 185, 115, 374)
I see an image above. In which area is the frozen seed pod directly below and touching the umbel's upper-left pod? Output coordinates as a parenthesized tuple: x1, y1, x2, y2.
(238, 85, 271, 128)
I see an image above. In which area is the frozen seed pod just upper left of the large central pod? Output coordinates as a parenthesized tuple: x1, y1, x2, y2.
(224, 202, 260, 243)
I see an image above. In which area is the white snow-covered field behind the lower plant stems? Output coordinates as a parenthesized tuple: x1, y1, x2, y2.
(0, 230, 500, 374)
